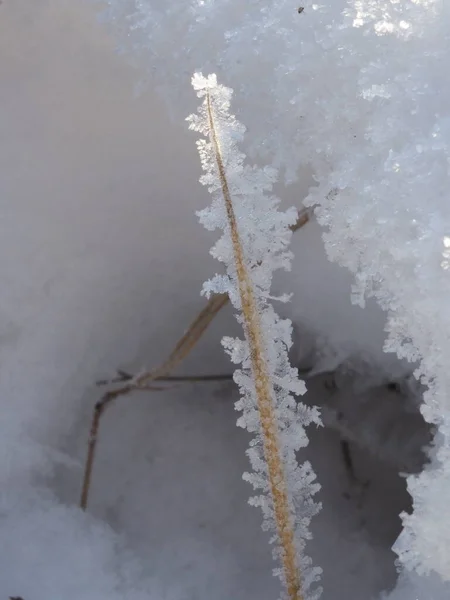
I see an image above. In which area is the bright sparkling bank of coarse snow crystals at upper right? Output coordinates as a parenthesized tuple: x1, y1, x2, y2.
(98, 0, 450, 592)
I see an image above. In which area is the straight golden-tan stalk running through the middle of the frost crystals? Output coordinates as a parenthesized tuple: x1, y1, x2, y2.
(207, 93, 303, 600)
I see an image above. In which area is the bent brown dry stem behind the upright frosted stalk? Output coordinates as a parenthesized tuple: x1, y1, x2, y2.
(80, 210, 310, 510)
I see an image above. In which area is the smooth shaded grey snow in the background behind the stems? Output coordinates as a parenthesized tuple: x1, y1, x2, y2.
(0, 0, 436, 600)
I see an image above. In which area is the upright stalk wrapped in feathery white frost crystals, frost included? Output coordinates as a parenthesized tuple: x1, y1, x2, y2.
(188, 74, 321, 600)
